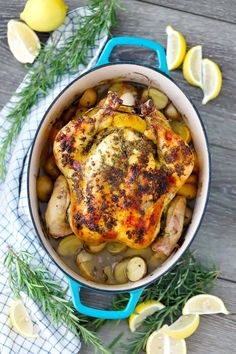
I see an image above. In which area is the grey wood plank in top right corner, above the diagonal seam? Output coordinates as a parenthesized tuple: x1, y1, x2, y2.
(137, 0, 236, 23)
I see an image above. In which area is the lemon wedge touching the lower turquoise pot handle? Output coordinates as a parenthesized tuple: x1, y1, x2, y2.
(129, 300, 165, 332)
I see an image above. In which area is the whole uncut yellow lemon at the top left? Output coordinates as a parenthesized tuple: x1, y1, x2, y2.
(20, 0, 67, 32)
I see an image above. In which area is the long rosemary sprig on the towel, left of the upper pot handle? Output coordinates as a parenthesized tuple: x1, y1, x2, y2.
(0, 0, 119, 180)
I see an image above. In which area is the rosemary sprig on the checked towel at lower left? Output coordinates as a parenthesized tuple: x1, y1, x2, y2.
(4, 248, 110, 354)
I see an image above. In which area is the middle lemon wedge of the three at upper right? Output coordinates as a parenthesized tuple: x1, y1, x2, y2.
(183, 45, 202, 88)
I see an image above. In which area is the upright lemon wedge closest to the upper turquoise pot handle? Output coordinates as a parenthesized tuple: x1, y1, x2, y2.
(166, 26, 186, 70)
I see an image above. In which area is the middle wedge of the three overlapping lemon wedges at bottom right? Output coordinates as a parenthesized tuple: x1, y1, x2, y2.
(162, 315, 200, 339)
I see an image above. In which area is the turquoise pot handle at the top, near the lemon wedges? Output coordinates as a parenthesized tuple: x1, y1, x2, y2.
(96, 37, 169, 75)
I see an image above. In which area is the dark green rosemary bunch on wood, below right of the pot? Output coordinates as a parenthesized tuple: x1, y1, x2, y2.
(112, 253, 218, 354)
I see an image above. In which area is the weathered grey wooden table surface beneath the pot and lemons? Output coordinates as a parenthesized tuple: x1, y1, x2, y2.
(0, 0, 236, 354)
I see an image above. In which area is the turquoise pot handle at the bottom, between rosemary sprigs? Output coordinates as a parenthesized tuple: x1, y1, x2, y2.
(68, 277, 144, 320)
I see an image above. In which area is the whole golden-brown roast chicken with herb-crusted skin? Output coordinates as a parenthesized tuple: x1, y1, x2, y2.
(54, 92, 193, 248)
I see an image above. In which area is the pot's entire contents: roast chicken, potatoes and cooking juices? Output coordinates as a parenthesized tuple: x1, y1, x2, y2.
(37, 82, 199, 284)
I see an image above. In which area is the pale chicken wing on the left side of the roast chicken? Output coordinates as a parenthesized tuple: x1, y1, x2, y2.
(45, 175, 72, 238)
